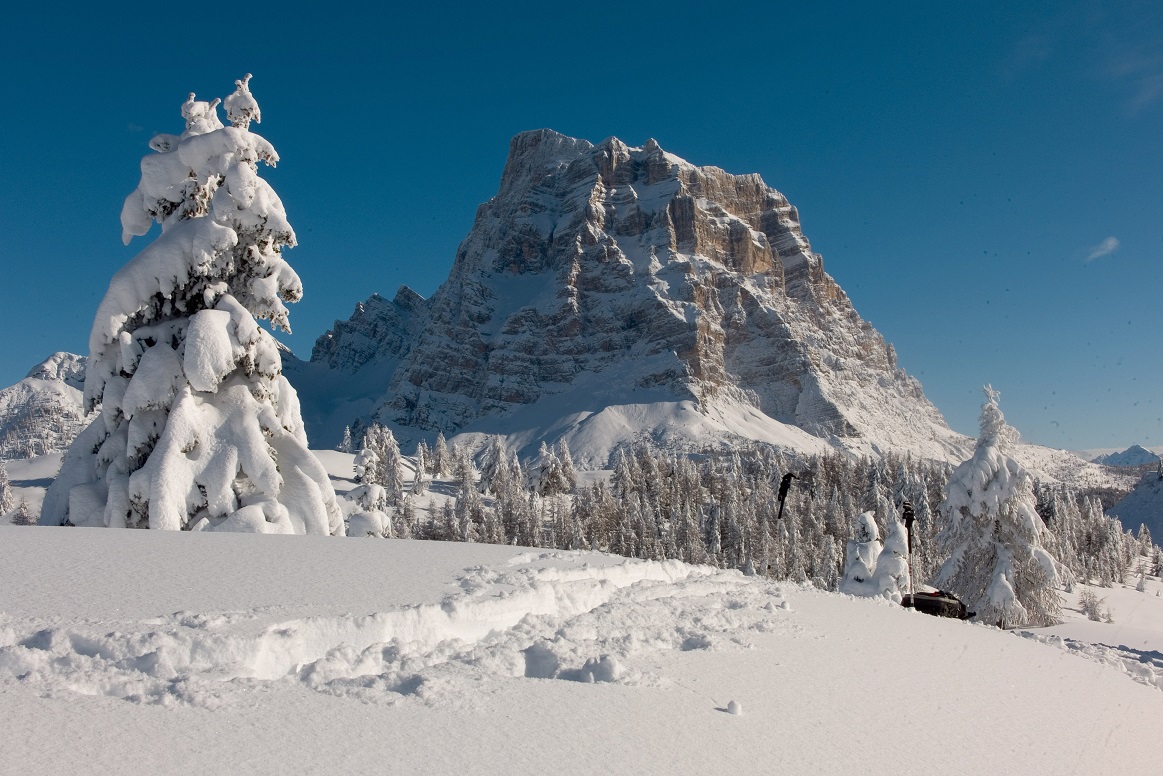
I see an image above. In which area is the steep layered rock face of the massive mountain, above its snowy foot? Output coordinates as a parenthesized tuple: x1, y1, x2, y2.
(313, 130, 954, 456)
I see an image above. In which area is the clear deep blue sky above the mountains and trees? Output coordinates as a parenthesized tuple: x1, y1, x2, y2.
(0, 2, 1163, 449)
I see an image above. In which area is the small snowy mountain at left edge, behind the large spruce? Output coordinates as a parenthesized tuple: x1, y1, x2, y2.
(0, 353, 92, 458)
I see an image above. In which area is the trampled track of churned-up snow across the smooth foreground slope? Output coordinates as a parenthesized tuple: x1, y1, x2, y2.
(0, 553, 792, 709)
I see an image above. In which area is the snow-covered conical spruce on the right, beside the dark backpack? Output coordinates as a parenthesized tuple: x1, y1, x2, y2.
(933, 385, 1061, 627)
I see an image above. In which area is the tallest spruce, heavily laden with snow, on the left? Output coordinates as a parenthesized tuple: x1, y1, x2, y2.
(41, 76, 343, 534)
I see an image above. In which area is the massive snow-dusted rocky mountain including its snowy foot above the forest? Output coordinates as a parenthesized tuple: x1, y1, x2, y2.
(285, 129, 1110, 483)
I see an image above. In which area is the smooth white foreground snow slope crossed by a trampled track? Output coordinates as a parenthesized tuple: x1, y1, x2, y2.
(0, 527, 1163, 775)
